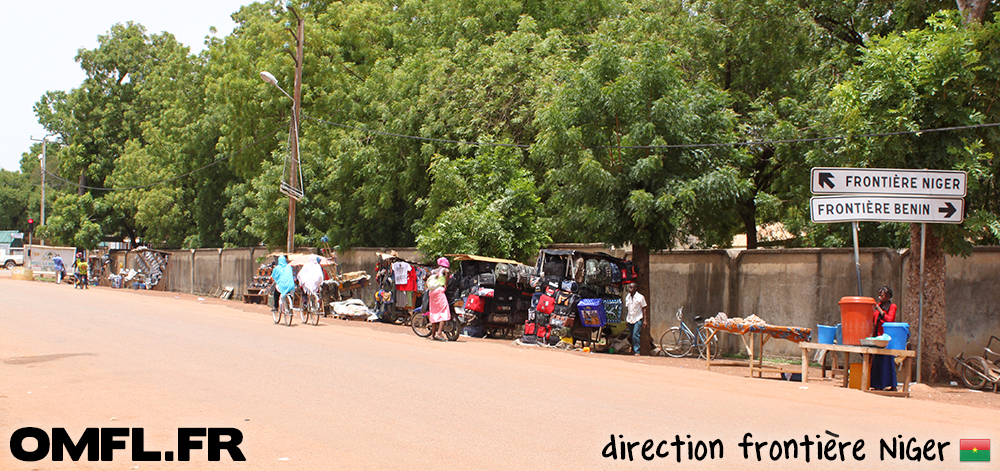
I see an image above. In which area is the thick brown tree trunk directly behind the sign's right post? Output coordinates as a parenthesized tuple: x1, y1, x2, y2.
(903, 224, 952, 383)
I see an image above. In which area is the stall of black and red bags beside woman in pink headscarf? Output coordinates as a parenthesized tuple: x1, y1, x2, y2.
(447, 254, 535, 338)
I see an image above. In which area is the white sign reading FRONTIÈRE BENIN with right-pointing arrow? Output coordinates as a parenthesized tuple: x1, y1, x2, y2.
(809, 195, 965, 224)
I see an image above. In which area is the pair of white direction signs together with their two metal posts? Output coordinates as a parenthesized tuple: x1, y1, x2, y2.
(809, 167, 968, 383)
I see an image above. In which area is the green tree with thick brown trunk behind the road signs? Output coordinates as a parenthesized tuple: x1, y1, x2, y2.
(829, 10, 1000, 381)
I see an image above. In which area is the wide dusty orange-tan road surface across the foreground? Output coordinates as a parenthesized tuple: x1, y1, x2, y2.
(0, 277, 1000, 471)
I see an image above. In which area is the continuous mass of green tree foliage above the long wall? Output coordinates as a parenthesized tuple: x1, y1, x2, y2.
(0, 0, 1000, 257)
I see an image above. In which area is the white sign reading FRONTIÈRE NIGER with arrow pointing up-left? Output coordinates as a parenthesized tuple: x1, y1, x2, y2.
(809, 167, 968, 197)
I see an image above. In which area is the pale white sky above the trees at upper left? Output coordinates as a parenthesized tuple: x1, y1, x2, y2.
(0, 0, 253, 171)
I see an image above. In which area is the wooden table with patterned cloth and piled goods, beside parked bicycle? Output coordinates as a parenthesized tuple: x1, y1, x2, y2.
(705, 313, 812, 378)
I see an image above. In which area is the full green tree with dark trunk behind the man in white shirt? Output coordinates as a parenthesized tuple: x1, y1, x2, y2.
(532, 15, 734, 349)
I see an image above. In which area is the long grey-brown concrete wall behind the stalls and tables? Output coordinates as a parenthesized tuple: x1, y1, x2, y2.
(143, 245, 1000, 357)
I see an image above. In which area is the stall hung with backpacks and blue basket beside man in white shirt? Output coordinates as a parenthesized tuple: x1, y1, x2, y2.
(521, 249, 638, 352)
